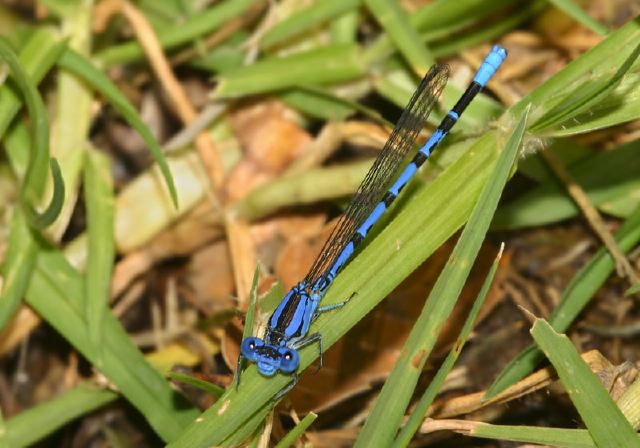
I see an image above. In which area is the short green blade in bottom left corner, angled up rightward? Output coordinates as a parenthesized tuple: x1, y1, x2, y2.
(1, 383, 118, 448)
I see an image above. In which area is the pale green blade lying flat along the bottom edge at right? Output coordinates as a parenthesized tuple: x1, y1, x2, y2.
(457, 423, 640, 448)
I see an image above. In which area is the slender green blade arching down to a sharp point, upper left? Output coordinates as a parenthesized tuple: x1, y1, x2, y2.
(58, 49, 178, 208)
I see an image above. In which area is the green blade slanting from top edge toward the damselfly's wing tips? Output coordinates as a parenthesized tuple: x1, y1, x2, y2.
(364, 0, 434, 74)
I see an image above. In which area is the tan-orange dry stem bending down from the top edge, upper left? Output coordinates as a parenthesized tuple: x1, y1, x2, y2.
(103, 0, 224, 191)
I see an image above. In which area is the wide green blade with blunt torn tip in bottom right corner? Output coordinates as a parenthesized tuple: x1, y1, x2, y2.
(531, 319, 640, 447)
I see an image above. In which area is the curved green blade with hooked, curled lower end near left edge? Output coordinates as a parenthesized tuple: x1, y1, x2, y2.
(0, 37, 64, 229)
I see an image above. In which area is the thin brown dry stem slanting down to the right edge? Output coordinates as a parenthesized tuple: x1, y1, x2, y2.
(542, 150, 640, 285)
